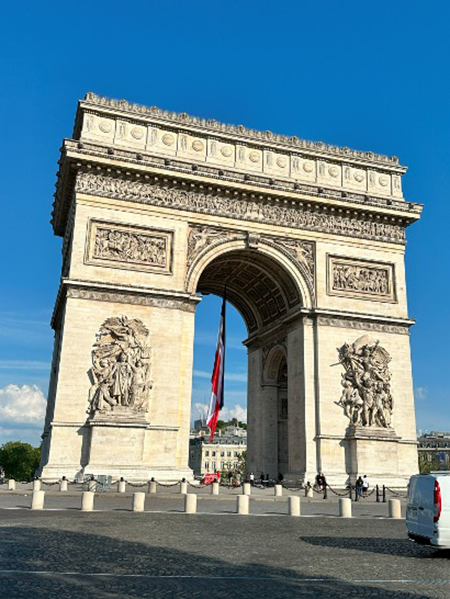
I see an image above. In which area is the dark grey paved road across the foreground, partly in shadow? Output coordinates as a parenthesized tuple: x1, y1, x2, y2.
(0, 506, 450, 599)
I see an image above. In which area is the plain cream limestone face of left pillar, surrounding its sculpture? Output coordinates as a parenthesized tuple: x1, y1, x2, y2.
(44, 297, 194, 478)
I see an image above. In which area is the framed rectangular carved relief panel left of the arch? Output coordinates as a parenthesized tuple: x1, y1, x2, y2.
(85, 220, 173, 274)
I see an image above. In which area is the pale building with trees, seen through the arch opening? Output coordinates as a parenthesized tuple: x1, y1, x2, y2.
(189, 426, 247, 476)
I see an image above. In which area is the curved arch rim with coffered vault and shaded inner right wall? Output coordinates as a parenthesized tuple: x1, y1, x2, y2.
(188, 241, 311, 477)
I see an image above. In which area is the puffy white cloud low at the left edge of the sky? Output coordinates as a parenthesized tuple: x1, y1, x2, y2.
(0, 385, 47, 429)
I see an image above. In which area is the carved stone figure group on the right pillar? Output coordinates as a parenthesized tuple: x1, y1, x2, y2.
(337, 335, 394, 428)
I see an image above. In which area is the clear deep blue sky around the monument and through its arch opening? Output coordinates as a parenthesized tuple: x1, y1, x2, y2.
(0, 0, 450, 443)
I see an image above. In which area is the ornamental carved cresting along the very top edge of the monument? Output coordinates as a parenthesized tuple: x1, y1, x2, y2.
(81, 92, 406, 171)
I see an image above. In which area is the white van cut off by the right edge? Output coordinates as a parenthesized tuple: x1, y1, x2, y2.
(406, 472, 450, 549)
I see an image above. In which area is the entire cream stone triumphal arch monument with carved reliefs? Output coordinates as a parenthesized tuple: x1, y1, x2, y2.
(40, 93, 421, 485)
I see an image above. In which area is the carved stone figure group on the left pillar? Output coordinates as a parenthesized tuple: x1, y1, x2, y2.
(88, 316, 152, 413)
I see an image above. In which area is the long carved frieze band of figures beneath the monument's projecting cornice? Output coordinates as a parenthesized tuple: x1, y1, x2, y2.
(75, 171, 405, 244)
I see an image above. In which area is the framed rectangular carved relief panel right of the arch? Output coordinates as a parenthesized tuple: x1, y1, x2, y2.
(327, 256, 396, 302)
